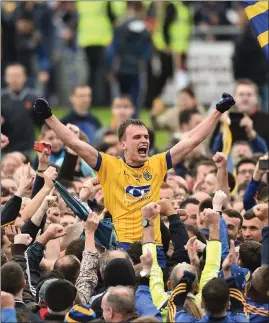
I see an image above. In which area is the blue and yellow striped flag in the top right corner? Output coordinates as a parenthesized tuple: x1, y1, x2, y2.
(244, 0, 269, 61)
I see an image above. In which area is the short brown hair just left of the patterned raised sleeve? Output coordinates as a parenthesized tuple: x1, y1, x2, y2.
(53, 255, 80, 285)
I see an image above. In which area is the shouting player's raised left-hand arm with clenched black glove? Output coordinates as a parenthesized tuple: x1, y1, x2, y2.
(33, 97, 99, 169)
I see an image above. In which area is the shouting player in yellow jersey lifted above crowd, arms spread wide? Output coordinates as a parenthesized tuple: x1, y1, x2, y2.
(33, 93, 235, 266)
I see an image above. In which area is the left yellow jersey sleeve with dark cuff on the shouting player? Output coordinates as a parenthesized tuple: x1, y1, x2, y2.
(94, 152, 120, 184)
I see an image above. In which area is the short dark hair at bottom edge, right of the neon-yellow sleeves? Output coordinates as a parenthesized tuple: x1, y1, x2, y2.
(202, 278, 230, 315)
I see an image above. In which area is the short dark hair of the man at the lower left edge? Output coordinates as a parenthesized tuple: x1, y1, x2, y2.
(1, 261, 25, 296)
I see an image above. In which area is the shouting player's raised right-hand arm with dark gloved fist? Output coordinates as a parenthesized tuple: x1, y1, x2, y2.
(170, 93, 235, 166)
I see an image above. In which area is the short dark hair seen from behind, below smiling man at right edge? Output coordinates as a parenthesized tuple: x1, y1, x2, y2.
(239, 240, 262, 272)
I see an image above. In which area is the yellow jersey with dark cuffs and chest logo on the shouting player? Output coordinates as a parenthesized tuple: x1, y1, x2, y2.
(95, 151, 172, 245)
